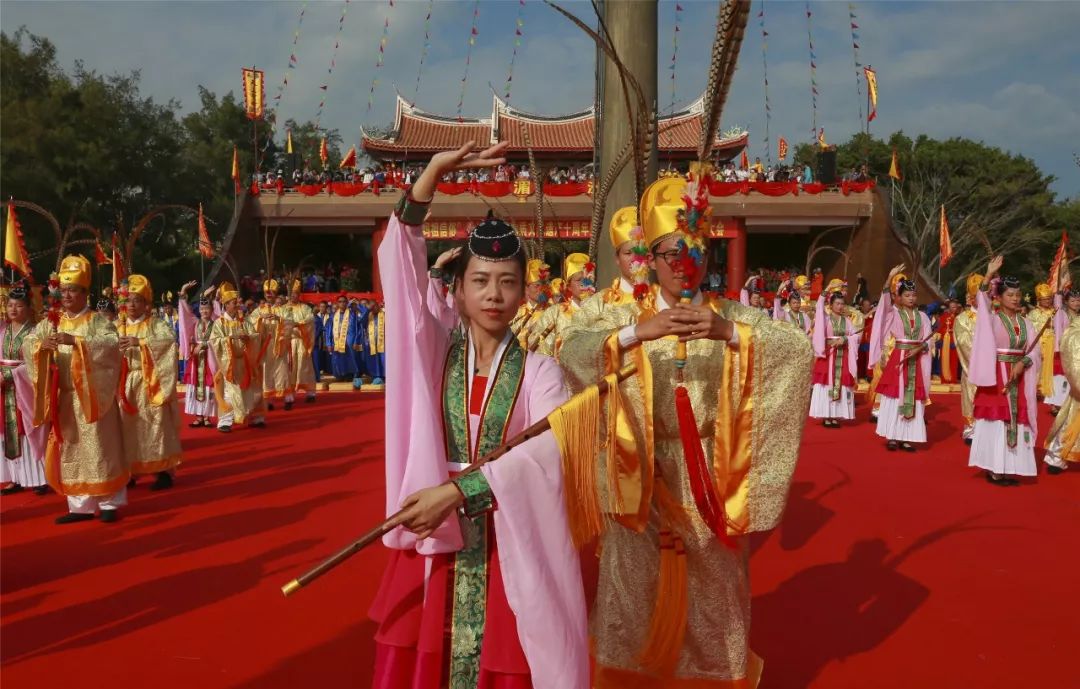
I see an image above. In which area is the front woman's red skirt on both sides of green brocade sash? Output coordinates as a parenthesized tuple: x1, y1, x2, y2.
(369, 518, 532, 689)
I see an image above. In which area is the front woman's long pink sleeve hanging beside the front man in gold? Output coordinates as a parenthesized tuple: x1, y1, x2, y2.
(481, 354, 589, 689)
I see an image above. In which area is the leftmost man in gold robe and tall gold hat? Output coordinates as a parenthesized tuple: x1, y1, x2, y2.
(23, 256, 131, 524)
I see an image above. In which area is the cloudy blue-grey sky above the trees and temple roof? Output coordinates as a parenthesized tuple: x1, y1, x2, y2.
(0, 0, 1080, 197)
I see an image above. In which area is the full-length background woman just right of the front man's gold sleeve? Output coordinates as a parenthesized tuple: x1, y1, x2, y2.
(810, 292, 862, 429)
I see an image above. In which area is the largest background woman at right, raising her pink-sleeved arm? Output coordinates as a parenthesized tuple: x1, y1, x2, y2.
(968, 256, 1042, 486)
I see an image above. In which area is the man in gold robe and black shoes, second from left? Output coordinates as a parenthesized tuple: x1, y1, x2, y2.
(116, 274, 183, 490)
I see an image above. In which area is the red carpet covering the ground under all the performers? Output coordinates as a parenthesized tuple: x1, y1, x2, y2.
(0, 393, 1080, 689)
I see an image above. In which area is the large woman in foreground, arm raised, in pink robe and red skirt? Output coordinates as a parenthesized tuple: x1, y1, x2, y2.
(370, 141, 589, 689)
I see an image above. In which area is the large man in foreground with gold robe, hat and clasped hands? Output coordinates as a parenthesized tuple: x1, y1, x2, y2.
(559, 178, 813, 689)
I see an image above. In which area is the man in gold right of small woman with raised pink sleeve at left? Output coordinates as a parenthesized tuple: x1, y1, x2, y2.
(210, 282, 266, 433)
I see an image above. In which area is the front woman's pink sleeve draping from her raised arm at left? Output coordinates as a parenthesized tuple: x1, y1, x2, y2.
(379, 216, 462, 555)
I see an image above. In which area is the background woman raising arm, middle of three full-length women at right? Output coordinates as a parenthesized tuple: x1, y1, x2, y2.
(869, 264, 931, 452)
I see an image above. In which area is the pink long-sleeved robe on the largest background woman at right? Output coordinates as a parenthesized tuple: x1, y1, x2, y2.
(968, 289, 1042, 435)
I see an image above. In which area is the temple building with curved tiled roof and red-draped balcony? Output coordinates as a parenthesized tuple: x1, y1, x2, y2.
(214, 95, 899, 293)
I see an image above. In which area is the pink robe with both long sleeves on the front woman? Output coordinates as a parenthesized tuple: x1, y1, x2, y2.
(379, 217, 589, 689)
